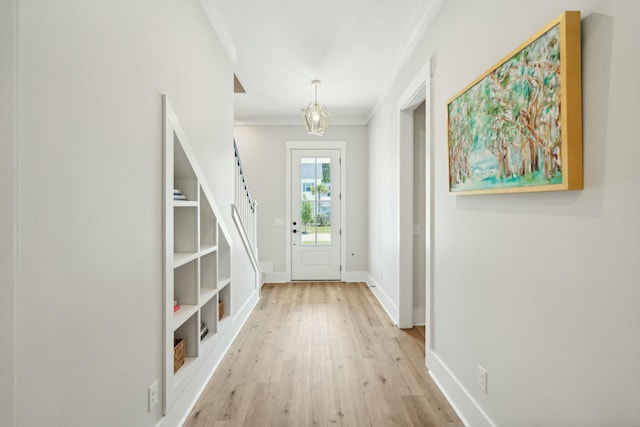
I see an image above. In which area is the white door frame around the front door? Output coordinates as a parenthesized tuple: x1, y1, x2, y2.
(284, 141, 347, 281)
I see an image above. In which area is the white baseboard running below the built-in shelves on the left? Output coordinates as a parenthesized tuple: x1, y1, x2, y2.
(156, 291, 260, 427)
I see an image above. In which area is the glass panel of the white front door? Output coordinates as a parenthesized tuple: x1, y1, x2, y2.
(300, 157, 331, 246)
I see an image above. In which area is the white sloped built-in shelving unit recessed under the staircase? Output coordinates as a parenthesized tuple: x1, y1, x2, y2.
(163, 96, 232, 414)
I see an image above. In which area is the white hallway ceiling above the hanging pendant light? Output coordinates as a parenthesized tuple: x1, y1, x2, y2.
(200, 0, 443, 124)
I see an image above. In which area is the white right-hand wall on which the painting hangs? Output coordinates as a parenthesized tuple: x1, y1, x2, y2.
(369, 0, 640, 426)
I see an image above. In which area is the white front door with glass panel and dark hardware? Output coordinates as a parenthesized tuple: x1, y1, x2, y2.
(289, 150, 341, 280)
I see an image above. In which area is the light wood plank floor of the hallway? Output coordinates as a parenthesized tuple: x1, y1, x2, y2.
(185, 282, 463, 427)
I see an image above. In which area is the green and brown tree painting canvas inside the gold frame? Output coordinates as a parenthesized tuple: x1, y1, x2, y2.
(448, 25, 562, 191)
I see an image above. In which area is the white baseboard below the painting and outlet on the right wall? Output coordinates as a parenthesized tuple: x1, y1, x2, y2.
(427, 351, 496, 427)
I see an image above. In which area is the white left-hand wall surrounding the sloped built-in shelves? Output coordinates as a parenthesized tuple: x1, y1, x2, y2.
(12, 0, 254, 426)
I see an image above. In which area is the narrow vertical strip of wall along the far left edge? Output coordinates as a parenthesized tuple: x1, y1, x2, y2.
(0, 1, 17, 426)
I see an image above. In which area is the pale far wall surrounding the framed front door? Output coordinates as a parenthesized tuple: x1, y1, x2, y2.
(234, 124, 368, 280)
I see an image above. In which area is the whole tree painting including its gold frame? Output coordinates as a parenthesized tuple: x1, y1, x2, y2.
(447, 12, 583, 195)
